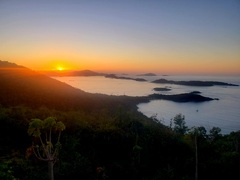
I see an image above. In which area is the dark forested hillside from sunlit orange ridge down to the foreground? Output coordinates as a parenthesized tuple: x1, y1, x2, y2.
(0, 63, 240, 180)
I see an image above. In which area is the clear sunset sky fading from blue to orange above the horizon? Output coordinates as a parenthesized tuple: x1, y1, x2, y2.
(0, 0, 240, 74)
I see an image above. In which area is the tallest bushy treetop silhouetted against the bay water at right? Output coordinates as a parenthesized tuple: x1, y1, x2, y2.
(173, 113, 188, 135)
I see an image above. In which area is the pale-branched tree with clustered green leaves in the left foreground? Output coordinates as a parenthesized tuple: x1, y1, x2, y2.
(28, 117, 65, 180)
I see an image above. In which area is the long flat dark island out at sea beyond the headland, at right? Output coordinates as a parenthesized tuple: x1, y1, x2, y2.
(152, 79, 239, 86)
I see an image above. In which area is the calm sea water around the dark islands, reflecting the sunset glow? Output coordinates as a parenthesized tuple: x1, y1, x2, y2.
(53, 75, 240, 134)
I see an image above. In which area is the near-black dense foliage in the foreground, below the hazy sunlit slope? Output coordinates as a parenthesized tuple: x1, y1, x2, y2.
(0, 106, 240, 180)
